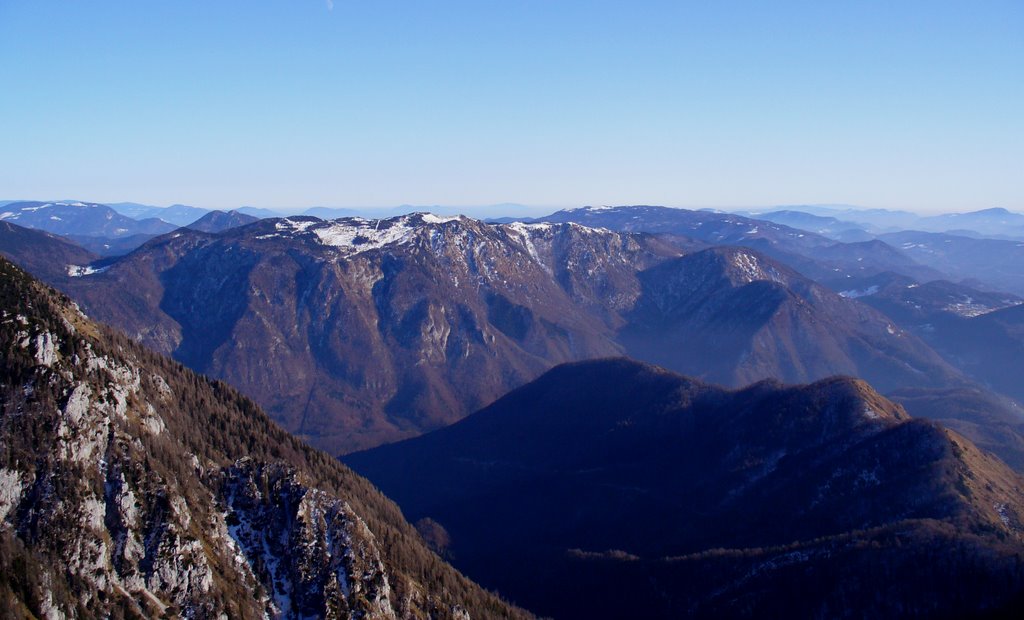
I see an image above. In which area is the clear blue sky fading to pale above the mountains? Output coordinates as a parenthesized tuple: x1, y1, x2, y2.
(0, 0, 1024, 211)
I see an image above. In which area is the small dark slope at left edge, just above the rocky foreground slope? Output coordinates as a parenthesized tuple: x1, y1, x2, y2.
(0, 221, 99, 282)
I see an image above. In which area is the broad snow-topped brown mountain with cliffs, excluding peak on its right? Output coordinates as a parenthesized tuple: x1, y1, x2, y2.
(55, 214, 679, 451)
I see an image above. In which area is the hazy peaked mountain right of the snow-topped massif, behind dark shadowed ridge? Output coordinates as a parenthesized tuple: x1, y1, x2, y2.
(618, 248, 965, 390)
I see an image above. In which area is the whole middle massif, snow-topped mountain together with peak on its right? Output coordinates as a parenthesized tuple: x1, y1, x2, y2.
(6, 214, 999, 453)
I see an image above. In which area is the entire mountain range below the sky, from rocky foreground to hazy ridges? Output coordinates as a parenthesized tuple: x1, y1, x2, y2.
(0, 201, 1024, 618)
